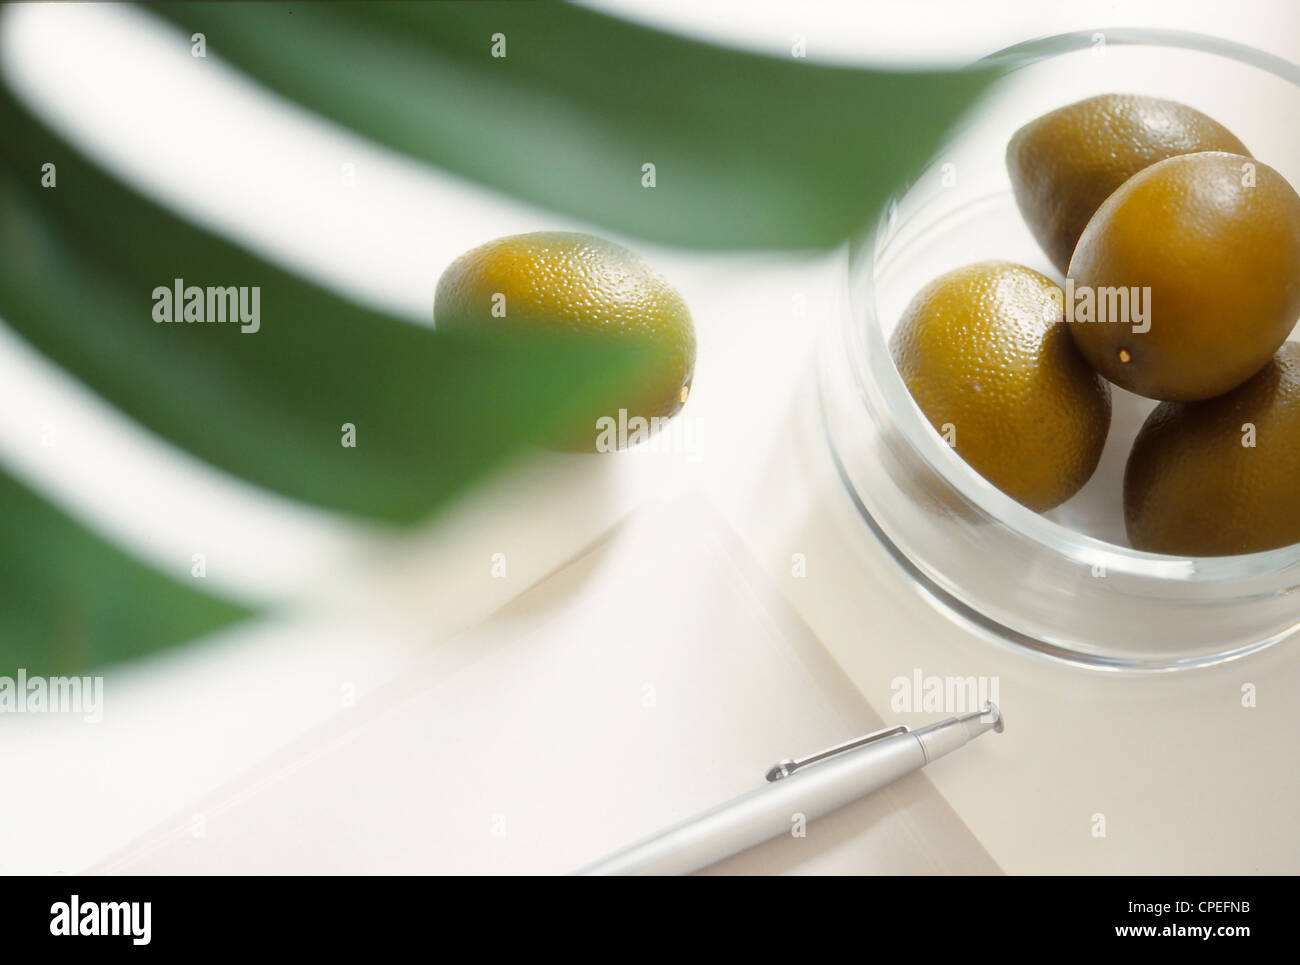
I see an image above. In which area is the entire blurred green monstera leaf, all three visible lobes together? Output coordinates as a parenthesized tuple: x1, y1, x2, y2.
(0, 3, 992, 674)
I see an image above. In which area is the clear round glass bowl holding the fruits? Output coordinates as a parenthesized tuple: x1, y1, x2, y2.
(820, 30, 1300, 670)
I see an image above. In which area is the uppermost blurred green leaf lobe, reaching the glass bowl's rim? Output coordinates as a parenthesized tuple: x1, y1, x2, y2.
(151, 3, 997, 248)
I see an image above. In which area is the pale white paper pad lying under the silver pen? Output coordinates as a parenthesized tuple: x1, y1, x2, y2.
(96, 499, 1000, 874)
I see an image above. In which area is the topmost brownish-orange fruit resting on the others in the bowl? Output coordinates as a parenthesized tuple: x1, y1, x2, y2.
(1066, 153, 1300, 402)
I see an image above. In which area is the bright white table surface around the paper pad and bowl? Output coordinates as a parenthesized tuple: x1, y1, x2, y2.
(0, 3, 1300, 873)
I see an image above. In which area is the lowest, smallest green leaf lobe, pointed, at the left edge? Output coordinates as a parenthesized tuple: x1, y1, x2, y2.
(0, 473, 248, 676)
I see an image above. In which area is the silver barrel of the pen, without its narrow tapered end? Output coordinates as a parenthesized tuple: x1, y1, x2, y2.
(580, 734, 926, 875)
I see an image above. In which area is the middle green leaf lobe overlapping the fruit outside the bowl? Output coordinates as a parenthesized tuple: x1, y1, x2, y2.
(0, 79, 657, 523)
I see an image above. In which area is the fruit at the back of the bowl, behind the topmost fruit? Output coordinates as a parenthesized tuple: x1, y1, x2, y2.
(1006, 94, 1249, 274)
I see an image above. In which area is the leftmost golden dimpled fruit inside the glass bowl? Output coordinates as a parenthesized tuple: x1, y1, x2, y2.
(889, 261, 1110, 511)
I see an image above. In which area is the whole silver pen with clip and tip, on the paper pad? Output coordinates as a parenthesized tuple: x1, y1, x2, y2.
(577, 702, 1002, 875)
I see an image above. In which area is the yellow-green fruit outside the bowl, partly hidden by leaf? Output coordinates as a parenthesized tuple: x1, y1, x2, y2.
(433, 231, 696, 451)
